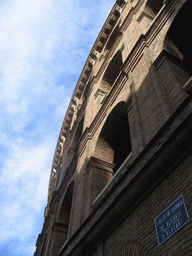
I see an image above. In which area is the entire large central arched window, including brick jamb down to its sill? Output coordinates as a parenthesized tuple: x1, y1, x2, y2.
(87, 101, 132, 205)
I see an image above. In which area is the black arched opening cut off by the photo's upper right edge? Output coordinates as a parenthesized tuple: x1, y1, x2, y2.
(165, 0, 192, 75)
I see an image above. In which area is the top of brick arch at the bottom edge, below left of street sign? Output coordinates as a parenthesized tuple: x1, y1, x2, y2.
(113, 242, 150, 256)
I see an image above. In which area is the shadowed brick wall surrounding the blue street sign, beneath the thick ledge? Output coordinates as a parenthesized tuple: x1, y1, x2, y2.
(99, 151, 192, 256)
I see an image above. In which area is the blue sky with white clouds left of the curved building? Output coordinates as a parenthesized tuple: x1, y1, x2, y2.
(0, 0, 115, 256)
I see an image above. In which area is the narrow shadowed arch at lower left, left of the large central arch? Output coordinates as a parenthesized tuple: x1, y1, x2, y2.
(50, 181, 74, 256)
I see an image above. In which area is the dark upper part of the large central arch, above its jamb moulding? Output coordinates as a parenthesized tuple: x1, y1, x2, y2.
(95, 102, 132, 173)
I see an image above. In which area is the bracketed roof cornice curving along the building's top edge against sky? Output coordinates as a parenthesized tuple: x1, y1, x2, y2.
(48, 0, 128, 203)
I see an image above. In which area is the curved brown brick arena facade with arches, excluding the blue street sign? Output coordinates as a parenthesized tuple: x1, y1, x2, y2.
(34, 0, 192, 256)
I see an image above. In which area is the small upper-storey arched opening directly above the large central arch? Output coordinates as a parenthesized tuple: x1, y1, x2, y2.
(101, 50, 123, 91)
